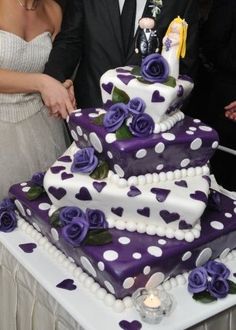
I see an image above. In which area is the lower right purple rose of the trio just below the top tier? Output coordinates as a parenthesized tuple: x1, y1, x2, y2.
(129, 113, 155, 137)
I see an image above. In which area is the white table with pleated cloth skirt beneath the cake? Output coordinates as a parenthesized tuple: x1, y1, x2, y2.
(0, 220, 236, 330)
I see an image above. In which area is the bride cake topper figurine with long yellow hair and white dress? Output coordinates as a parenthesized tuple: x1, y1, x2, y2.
(161, 16, 188, 78)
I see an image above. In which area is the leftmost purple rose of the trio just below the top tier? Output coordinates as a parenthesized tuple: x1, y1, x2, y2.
(103, 103, 128, 132)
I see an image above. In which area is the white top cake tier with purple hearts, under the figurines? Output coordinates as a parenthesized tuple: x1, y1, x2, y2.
(100, 66, 193, 133)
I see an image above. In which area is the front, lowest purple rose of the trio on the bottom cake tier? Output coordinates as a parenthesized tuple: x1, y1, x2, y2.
(62, 218, 89, 247)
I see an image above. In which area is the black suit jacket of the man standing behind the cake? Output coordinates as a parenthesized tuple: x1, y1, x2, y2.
(45, 0, 198, 108)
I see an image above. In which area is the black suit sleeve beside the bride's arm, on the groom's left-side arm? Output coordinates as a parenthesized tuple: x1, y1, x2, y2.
(44, 0, 84, 82)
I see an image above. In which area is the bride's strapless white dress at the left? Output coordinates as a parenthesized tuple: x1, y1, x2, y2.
(0, 30, 66, 200)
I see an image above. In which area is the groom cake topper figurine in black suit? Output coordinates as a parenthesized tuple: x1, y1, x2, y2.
(135, 17, 160, 58)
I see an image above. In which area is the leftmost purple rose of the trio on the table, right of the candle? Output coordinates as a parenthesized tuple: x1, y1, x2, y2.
(188, 267, 208, 293)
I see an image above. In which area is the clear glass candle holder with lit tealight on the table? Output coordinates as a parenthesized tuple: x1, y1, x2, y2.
(132, 288, 173, 324)
